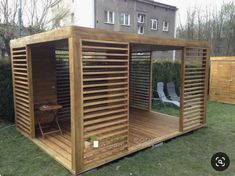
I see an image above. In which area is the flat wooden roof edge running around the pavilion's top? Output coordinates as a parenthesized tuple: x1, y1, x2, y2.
(10, 26, 210, 48)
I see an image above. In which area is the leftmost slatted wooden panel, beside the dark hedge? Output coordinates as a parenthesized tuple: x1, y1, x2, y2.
(12, 47, 34, 137)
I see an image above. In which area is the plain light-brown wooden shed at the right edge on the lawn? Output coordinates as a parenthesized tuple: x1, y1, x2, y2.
(210, 56, 235, 104)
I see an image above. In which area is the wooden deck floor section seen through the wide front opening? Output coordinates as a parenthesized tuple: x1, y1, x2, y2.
(129, 109, 179, 150)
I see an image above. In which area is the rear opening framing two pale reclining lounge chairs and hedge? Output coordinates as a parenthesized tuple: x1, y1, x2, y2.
(152, 50, 182, 117)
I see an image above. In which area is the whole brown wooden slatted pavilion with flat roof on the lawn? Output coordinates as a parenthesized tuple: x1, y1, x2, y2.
(11, 26, 209, 173)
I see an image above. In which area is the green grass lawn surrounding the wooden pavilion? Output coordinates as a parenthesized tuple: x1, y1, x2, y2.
(0, 102, 235, 176)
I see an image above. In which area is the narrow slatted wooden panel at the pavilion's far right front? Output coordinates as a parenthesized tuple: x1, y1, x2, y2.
(180, 48, 208, 131)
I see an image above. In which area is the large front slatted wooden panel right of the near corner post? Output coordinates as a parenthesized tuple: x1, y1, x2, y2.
(82, 41, 129, 168)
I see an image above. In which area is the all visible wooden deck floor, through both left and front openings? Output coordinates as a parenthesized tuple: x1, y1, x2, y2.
(34, 109, 179, 170)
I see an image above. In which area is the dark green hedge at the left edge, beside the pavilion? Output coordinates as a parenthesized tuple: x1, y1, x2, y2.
(0, 59, 14, 121)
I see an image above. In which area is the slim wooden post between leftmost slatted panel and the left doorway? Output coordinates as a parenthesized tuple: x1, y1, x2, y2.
(26, 46, 35, 138)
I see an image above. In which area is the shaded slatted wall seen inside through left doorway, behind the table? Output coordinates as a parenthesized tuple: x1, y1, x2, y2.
(55, 50, 70, 120)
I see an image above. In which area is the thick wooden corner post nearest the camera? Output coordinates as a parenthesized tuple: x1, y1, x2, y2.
(69, 37, 84, 173)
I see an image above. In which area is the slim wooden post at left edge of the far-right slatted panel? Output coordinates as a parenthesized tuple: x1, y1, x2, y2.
(179, 47, 186, 132)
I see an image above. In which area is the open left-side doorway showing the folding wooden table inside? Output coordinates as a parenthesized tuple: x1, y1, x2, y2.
(30, 40, 71, 168)
